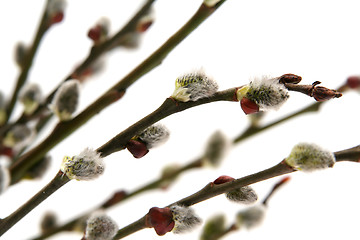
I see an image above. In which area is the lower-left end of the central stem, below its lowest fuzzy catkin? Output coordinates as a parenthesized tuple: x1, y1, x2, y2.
(0, 171, 70, 236)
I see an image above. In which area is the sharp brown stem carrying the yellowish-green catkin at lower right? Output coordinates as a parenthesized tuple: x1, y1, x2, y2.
(113, 146, 360, 239)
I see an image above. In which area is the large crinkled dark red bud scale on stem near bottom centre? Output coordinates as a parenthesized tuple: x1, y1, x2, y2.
(145, 207, 175, 236)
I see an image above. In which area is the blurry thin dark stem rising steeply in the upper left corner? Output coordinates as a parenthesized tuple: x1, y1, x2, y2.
(4, 0, 48, 124)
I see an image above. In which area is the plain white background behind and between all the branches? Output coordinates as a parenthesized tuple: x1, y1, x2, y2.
(0, 0, 360, 240)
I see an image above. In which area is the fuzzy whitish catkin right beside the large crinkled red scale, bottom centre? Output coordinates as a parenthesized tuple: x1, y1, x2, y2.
(170, 205, 202, 234)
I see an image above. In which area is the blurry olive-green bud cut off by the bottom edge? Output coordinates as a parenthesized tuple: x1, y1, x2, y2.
(200, 215, 226, 240)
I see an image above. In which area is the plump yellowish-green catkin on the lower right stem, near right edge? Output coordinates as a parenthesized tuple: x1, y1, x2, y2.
(285, 143, 335, 172)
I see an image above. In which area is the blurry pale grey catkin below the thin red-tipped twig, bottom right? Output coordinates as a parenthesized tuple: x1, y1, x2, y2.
(236, 205, 266, 229)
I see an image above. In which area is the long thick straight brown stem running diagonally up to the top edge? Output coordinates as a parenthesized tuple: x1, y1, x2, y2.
(10, 0, 231, 184)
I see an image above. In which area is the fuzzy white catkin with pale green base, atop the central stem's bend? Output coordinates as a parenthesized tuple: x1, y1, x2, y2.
(171, 71, 218, 102)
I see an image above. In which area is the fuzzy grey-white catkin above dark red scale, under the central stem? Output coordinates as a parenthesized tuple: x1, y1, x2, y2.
(138, 124, 170, 149)
